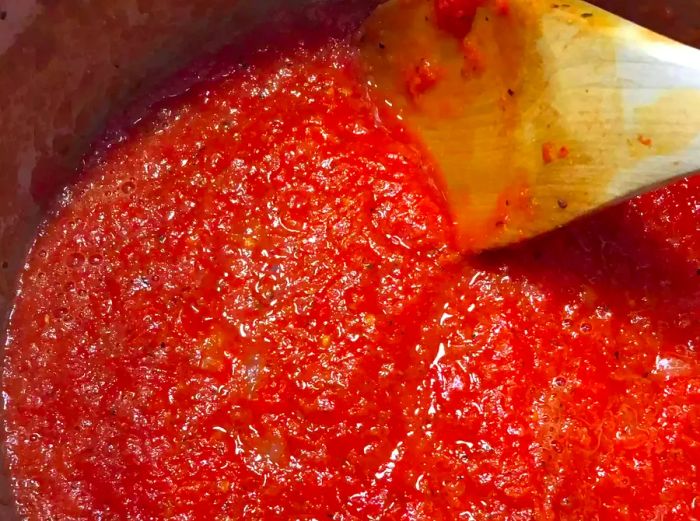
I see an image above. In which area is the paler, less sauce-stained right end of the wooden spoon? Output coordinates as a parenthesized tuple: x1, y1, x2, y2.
(540, 1, 700, 206)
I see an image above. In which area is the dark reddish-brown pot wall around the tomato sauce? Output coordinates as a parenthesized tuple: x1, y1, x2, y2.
(0, 0, 700, 521)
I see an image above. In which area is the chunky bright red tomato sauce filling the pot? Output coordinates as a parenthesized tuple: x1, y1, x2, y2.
(4, 2, 700, 521)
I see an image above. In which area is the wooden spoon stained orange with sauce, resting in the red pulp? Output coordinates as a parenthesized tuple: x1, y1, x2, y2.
(360, 0, 700, 250)
